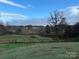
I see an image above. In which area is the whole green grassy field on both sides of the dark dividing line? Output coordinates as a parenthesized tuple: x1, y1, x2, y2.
(0, 35, 79, 59)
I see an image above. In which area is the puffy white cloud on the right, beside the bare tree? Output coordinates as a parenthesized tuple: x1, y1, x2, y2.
(60, 6, 79, 24)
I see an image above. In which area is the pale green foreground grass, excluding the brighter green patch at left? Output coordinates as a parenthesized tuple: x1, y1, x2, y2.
(0, 42, 79, 59)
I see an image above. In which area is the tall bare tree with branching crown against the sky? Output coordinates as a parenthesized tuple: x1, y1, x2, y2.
(48, 11, 67, 36)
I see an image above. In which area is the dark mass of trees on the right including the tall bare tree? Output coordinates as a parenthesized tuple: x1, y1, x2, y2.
(42, 11, 79, 41)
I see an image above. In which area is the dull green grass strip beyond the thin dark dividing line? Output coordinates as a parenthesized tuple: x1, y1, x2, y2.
(0, 35, 52, 42)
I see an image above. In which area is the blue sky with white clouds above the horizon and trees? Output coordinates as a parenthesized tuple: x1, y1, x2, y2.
(0, 0, 79, 25)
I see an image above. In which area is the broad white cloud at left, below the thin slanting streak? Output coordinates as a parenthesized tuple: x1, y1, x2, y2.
(0, 12, 28, 25)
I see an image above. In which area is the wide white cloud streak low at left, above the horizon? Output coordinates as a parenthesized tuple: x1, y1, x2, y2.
(0, 12, 28, 21)
